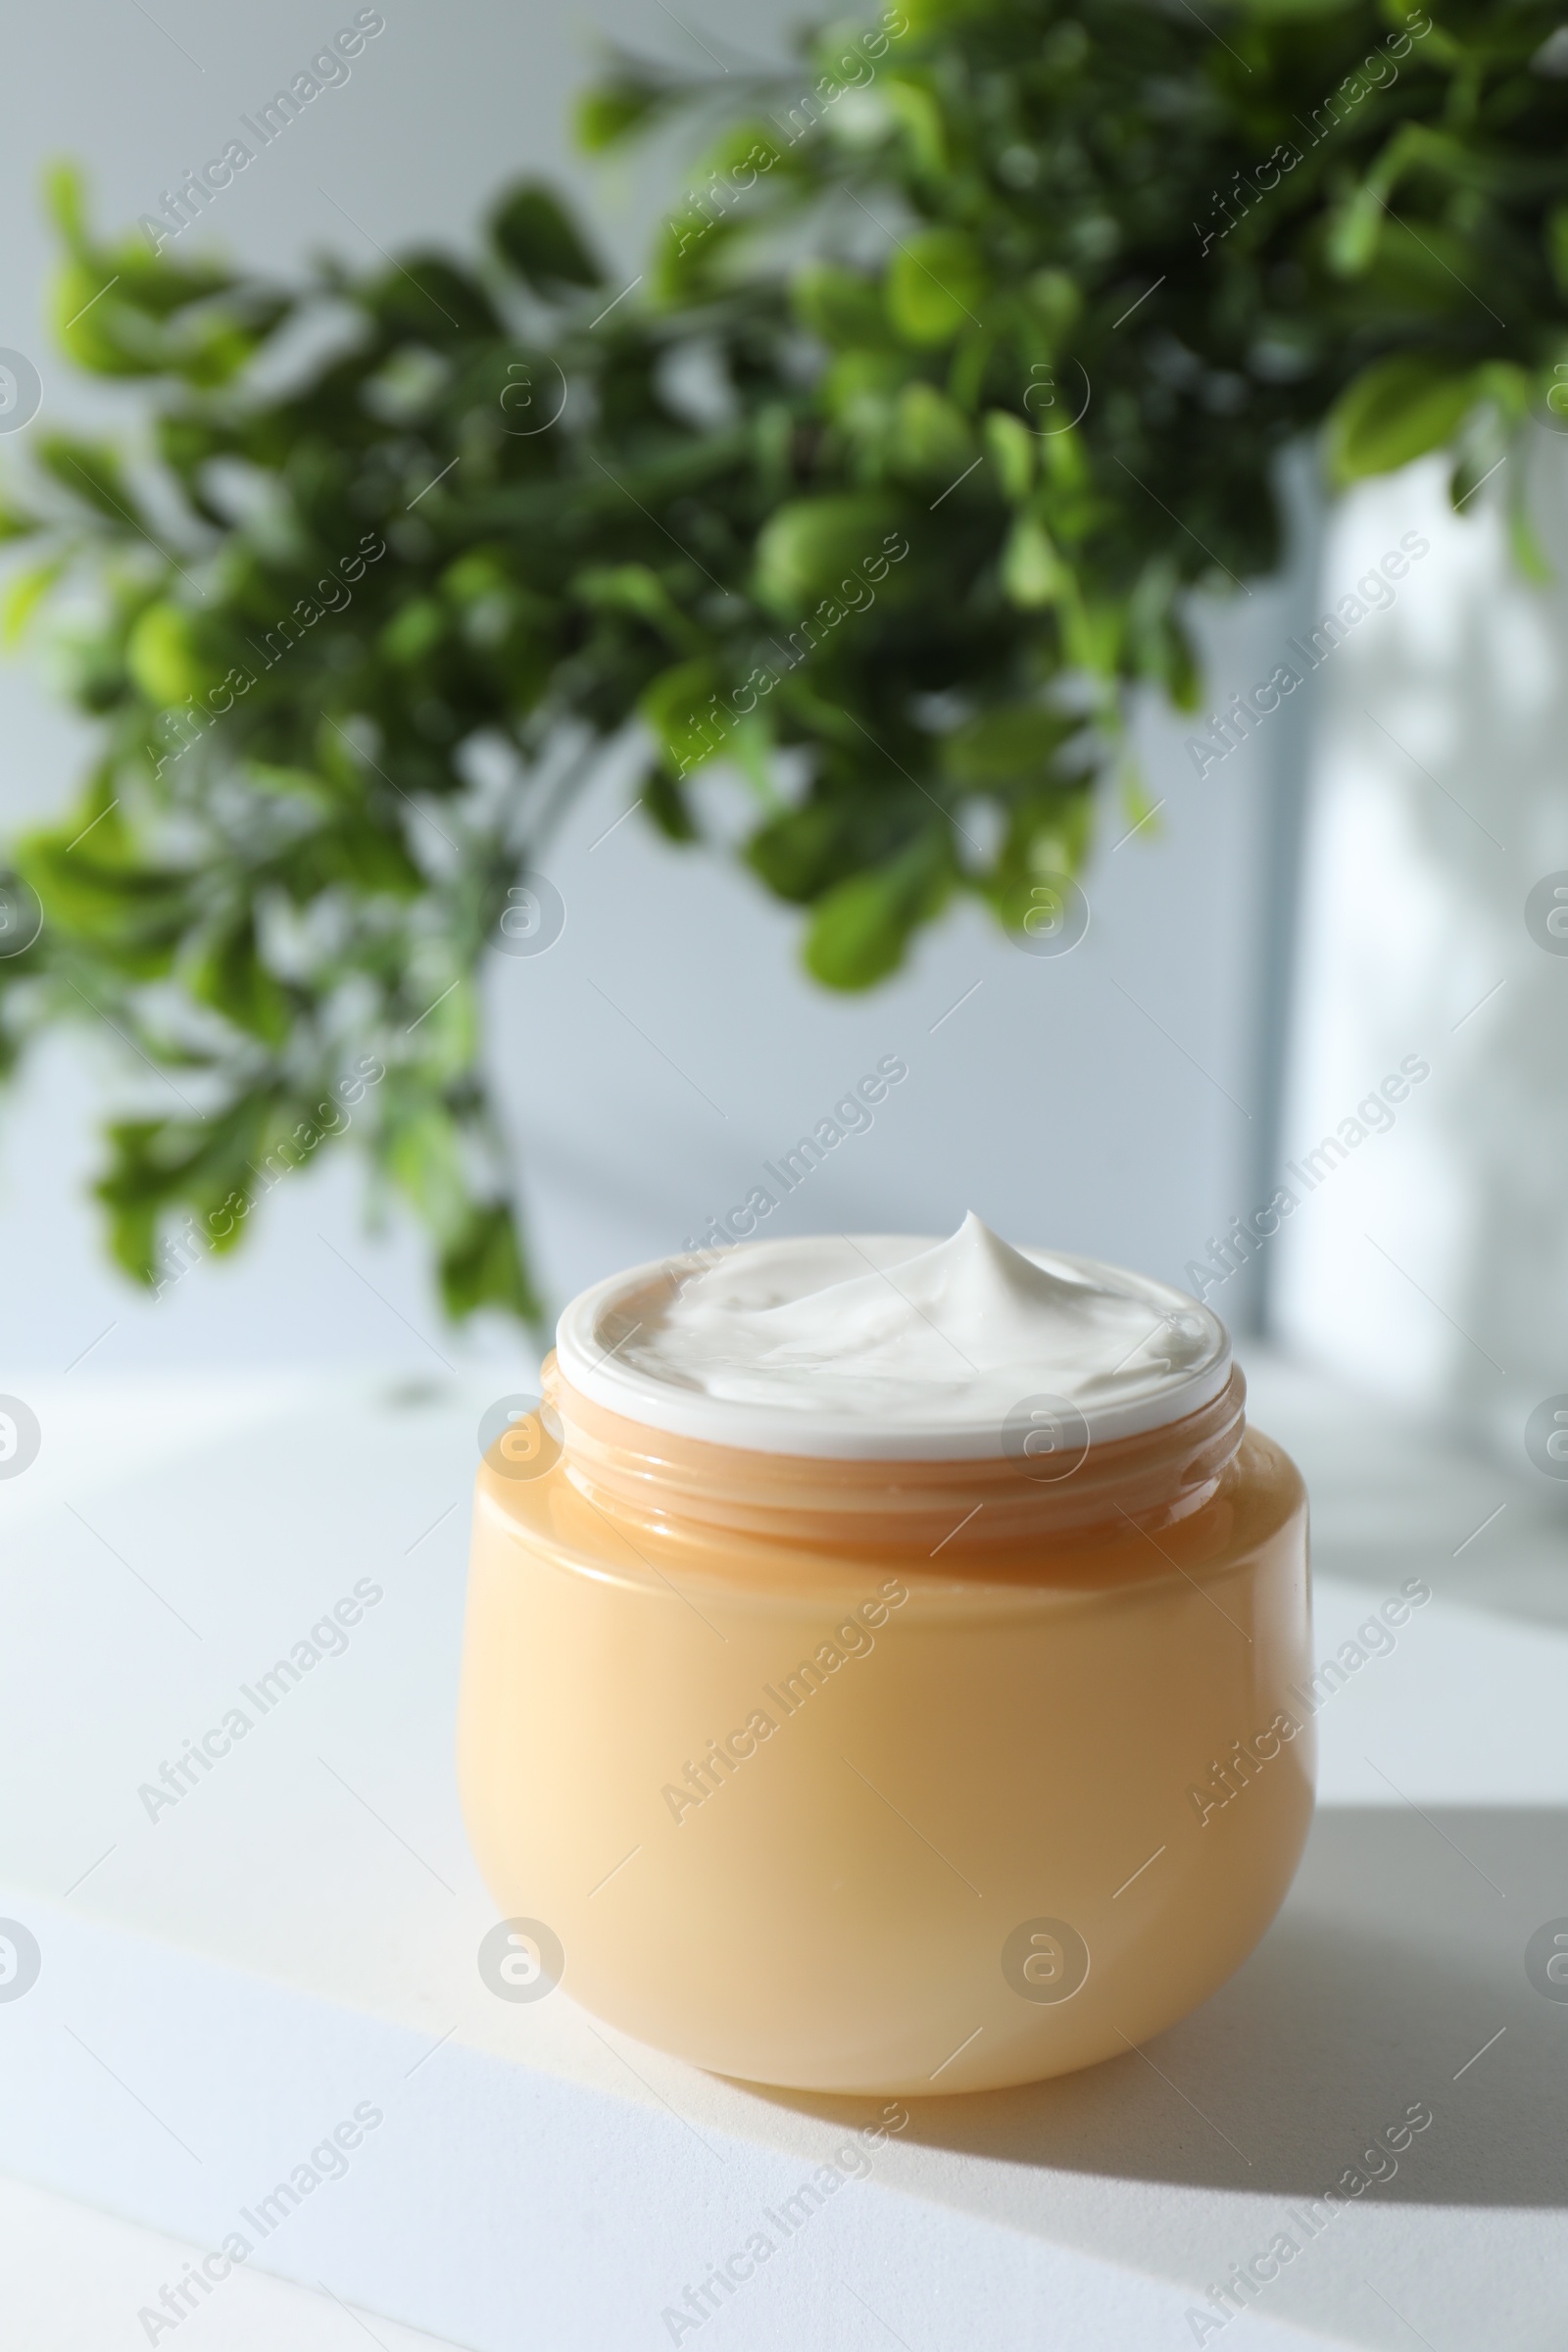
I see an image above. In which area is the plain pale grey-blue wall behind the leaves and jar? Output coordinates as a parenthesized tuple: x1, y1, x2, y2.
(0, 0, 1296, 1374)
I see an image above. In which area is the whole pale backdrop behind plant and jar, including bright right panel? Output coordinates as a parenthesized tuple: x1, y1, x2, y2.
(0, 0, 1568, 1460)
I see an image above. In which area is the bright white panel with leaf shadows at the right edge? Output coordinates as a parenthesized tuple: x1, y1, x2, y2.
(1277, 428, 1568, 1458)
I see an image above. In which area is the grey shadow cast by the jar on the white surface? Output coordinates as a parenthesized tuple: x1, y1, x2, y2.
(757, 1806, 1568, 2206)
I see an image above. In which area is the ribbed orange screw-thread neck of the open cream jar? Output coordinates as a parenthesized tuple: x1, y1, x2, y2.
(541, 1354, 1246, 1569)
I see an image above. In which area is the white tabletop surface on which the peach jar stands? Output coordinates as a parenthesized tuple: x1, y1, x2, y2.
(0, 1362, 1568, 2352)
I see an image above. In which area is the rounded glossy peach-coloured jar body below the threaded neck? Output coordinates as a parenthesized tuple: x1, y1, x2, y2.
(459, 1433, 1314, 2095)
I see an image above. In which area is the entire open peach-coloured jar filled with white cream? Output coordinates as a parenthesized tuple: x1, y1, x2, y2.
(459, 1216, 1314, 2095)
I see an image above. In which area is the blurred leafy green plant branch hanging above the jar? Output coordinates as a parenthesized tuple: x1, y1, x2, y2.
(0, 0, 1568, 1315)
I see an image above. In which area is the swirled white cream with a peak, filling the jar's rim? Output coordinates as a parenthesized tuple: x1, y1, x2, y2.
(558, 1213, 1230, 1460)
